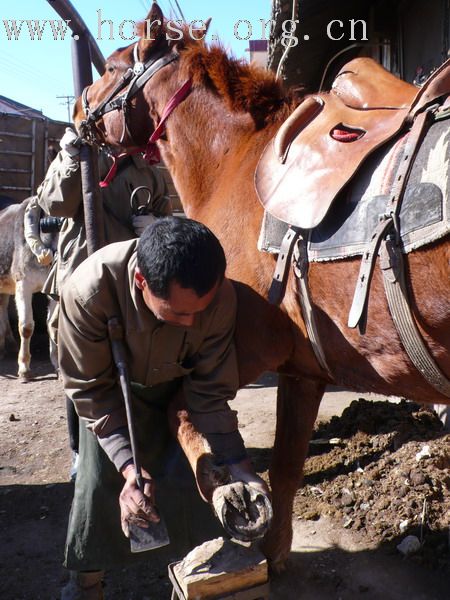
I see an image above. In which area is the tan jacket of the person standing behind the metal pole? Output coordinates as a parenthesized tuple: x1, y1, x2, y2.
(37, 152, 172, 296)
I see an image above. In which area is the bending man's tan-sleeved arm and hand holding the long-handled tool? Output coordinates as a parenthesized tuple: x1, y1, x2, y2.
(58, 278, 159, 536)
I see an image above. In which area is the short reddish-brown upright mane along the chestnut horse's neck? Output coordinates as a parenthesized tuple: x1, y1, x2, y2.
(138, 24, 298, 129)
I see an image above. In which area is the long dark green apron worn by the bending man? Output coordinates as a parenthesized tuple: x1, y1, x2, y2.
(64, 380, 223, 571)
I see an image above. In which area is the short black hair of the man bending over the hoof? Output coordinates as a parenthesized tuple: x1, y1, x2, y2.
(137, 217, 226, 299)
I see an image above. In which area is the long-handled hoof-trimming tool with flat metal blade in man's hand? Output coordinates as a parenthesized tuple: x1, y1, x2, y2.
(108, 317, 170, 552)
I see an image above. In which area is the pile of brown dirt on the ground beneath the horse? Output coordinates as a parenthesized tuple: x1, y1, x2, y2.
(294, 398, 450, 569)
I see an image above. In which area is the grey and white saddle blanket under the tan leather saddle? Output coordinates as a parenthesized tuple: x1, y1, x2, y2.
(259, 119, 450, 262)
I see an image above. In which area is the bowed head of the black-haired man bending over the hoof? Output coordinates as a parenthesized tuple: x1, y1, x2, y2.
(136, 217, 226, 326)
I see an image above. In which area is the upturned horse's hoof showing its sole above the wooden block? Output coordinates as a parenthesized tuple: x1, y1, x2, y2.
(212, 481, 273, 542)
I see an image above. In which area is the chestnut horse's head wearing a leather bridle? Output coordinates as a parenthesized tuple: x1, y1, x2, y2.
(74, 2, 208, 152)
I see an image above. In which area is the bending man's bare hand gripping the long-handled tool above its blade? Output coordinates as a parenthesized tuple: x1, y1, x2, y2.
(119, 464, 160, 537)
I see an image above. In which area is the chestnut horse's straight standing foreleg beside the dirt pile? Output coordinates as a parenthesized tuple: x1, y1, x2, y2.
(263, 376, 325, 570)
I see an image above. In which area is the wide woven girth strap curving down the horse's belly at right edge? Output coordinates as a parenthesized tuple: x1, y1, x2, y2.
(380, 239, 450, 398)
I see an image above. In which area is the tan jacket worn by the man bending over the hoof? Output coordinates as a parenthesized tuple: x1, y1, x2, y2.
(59, 240, 238, 437)
